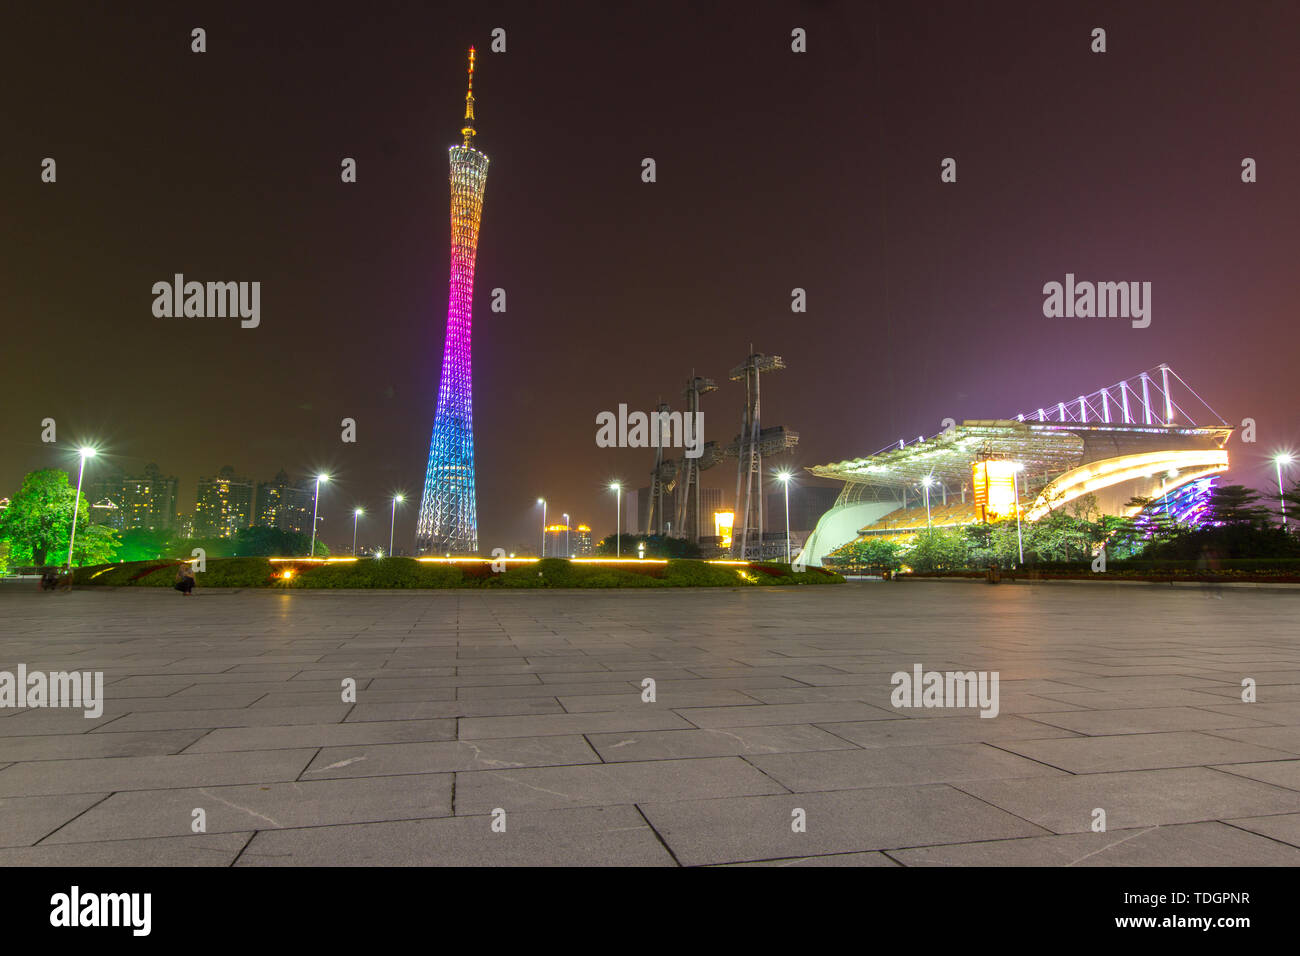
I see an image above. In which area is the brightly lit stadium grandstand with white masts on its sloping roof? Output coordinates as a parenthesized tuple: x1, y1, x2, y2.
(798, 365, 1232, 564)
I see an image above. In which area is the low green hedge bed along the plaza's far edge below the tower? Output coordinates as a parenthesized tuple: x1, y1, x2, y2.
(75, 558, 844, 588)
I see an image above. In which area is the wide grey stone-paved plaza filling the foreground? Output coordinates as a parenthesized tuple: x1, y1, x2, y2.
(0, 583, 1300, 866)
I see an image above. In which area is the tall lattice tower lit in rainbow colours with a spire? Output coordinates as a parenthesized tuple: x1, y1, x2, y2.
(415, 47, 488, 554)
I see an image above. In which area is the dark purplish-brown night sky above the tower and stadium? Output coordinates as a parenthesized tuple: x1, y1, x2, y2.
(0, 0, 1300, 551)
